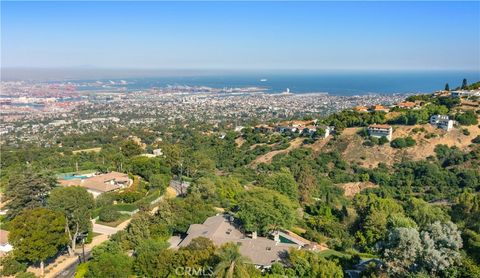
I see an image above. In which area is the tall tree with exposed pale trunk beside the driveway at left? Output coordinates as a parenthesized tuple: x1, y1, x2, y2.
(47, 186, 95, 256)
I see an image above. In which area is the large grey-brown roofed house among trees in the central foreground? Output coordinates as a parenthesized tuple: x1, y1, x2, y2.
(174, 214, 304, 269)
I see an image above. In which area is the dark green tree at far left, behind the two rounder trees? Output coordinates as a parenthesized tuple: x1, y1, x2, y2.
(3, 166, 57, 219)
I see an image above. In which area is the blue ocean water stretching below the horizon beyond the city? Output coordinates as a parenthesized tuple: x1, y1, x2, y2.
(69, 71, 480, 96)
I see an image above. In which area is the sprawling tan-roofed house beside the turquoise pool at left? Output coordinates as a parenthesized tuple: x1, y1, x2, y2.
(58, 172, 133, 198)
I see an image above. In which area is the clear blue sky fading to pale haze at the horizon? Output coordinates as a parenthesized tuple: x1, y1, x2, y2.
(1, 1, 480, 70)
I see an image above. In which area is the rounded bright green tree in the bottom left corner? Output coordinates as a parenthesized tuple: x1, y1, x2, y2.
(8, 208, 68, 276)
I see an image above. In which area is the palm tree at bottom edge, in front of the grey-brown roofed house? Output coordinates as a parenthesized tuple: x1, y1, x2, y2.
(213, 243, 250, 278)
